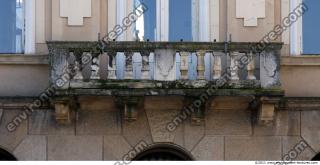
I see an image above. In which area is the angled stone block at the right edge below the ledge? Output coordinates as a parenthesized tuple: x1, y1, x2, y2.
(301, 111, 320, 152)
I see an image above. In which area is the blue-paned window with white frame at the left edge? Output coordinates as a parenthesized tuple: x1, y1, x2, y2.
(0, 0, 24, 53)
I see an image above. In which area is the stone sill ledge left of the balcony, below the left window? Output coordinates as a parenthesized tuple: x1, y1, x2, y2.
(0, 54, 49, 65)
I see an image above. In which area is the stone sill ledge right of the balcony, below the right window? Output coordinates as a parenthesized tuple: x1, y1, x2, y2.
(281, 55, 320, 66)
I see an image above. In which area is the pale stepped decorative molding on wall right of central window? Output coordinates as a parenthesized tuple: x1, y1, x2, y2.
(236, 0, 266, 27)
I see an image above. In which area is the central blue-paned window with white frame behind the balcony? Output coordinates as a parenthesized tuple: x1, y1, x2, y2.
(134, 0, 209, 42)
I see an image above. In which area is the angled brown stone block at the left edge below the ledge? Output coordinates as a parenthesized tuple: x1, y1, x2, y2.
(0, 110, 28, 151)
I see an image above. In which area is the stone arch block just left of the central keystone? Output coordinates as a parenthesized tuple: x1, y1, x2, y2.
(122, 109, 152, 146)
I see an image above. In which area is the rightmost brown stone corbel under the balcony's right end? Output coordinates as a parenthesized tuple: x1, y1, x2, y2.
(257, 97, 280, 126)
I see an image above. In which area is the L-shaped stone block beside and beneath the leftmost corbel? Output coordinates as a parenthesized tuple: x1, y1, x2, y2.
(28, 110, 75, 135)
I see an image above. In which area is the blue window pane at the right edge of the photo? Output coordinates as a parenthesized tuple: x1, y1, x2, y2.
(302, 0, 320, 54)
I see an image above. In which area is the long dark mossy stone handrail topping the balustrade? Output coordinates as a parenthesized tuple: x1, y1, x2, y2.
(47, 41, 283, 53)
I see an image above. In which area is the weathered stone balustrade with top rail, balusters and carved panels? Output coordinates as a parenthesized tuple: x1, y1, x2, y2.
(48, 41, 282, 94)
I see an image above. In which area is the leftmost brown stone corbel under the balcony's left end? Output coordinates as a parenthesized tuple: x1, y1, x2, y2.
(53, 97, 76, 124)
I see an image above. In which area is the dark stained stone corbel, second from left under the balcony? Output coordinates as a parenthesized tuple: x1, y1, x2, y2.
(117, 96, 143, 121)
